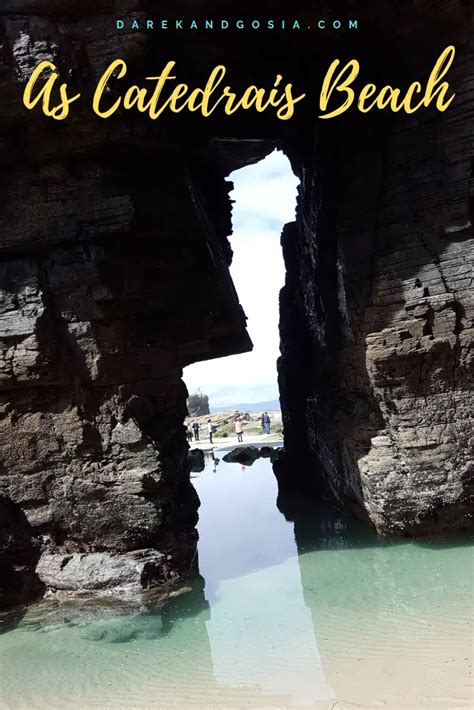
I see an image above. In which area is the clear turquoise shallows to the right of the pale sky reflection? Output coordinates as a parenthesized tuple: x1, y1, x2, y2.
(286, 499, 472, 708)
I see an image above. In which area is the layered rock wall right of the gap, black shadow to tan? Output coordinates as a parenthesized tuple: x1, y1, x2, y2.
(279, 14, 474, 535)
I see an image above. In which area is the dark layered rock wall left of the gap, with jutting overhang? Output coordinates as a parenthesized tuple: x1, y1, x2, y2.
(0, 3, 250, 602)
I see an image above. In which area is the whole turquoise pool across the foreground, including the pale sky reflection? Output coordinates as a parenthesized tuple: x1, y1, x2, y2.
(0, 459, 473, 710)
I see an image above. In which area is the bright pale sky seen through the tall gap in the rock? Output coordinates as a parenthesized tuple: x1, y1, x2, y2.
(183, 150, 298, 407)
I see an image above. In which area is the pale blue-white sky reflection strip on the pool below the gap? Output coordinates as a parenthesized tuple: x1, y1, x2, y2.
(194, 459, 332, 702)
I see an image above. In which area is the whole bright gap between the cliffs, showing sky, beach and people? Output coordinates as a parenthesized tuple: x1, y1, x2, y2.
(183, 150, 298, 453)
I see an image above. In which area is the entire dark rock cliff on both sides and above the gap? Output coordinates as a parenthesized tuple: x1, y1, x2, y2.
(0, 0, 474, 612)
